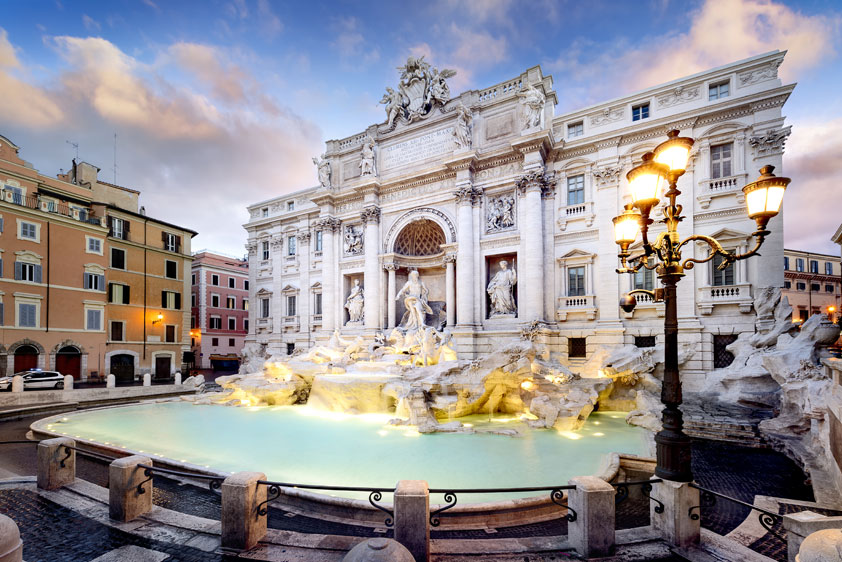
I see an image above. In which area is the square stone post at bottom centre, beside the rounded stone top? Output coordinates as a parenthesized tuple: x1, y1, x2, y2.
(395, 480, 430, 562)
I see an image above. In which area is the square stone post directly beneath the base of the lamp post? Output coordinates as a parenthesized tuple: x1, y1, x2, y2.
(650, 480, 701, 548)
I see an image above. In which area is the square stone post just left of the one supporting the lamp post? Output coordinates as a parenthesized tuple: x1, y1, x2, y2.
(567, 476, 616, 558)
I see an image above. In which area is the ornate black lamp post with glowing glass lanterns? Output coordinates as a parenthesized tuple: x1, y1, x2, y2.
(614, 130, 790, 482)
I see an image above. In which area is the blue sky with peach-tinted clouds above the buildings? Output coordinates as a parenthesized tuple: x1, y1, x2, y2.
(0, 0, 842, 256)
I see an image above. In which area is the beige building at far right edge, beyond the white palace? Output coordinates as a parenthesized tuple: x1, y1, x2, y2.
(783, 249, 842, 322)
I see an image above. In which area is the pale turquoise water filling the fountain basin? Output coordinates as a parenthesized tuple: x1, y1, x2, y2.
(49, 402, 647, 503)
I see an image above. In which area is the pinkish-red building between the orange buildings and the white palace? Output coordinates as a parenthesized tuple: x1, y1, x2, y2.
(190, 250, 249, 369)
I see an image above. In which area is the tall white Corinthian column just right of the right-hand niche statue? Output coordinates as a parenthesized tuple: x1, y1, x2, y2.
(517, 170, 552, 322)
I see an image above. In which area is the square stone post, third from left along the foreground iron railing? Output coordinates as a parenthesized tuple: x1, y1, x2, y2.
(222, 472, 269, 551)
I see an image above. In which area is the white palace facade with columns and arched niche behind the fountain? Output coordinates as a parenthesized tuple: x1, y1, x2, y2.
(245, 51, 797, 384)
